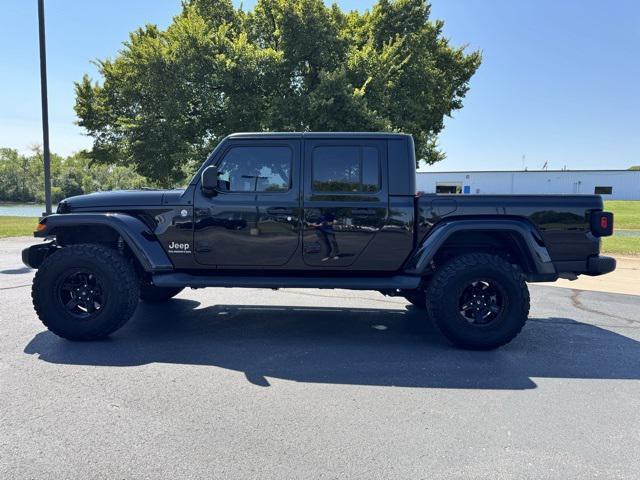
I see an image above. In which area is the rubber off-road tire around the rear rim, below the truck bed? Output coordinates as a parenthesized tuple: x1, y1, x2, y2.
(426, 253, 529, 350)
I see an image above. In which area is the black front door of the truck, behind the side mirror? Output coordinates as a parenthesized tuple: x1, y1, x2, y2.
(194, 139, 301, 268)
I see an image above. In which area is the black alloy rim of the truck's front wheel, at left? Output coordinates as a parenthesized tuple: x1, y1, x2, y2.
(58, 269, 106, 320)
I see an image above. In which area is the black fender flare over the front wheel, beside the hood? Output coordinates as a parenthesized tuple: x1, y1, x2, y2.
(35, 213, 173, 273)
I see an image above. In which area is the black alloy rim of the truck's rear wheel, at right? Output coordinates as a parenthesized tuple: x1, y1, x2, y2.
(458, 279, 506, 327)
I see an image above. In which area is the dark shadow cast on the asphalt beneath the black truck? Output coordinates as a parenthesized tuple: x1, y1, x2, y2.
(24, 299, 640, 390)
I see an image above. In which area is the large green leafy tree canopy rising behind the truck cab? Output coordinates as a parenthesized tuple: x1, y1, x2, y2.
(75, 0, 481, 184)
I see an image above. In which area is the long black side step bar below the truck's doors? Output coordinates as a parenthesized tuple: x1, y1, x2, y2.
(152, 273, 421, 290)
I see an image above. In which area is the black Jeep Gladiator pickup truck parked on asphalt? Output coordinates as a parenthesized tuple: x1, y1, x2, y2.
(22, 133, 615, 349)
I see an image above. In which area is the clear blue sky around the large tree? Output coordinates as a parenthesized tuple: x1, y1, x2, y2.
(0, 0, 640, 170)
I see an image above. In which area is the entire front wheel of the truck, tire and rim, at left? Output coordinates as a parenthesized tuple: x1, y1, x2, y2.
(31, 244, 139, 340)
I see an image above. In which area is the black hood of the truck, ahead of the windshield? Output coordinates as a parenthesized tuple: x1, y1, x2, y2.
(58, 190, 183, 213)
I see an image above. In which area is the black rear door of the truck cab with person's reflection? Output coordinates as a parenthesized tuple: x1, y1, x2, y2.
(303, 138, 388, 268)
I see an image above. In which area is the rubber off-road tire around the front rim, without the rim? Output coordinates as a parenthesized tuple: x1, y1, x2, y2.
(31, 244, 140, 341)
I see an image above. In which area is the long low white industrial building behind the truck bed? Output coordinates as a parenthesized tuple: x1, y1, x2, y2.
(417, 170, 640, 200)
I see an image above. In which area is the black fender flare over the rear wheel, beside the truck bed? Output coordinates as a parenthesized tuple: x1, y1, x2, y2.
(404, 219, 557, 277)
